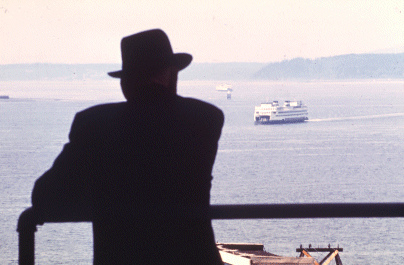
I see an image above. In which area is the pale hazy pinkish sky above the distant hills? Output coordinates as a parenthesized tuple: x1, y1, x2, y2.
(0, 0, 404, 64)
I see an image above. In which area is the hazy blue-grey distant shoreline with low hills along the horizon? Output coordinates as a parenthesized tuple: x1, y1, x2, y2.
(0, 53, 404, 81)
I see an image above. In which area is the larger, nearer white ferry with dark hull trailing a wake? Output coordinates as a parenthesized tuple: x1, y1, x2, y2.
(254, 100, 309, 124)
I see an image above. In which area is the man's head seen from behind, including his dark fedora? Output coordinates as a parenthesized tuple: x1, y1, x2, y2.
(108, 29, 192, 98)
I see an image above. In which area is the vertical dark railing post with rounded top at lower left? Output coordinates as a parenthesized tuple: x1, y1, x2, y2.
(17, 208, 37, 265)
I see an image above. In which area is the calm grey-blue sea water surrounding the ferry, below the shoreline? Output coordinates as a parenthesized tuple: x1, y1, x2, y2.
(0, 80, 404, 264)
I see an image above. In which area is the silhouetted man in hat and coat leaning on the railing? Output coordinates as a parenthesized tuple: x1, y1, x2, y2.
(32, 30, 224, 265)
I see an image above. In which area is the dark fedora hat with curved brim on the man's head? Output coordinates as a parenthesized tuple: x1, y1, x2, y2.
(108, 29, 192, 79)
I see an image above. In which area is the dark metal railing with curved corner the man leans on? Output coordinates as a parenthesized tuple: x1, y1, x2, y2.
(17, 203, 404, 265)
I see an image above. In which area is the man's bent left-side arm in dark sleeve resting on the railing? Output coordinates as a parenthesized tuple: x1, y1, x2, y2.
(32, 112, 92, 219)
